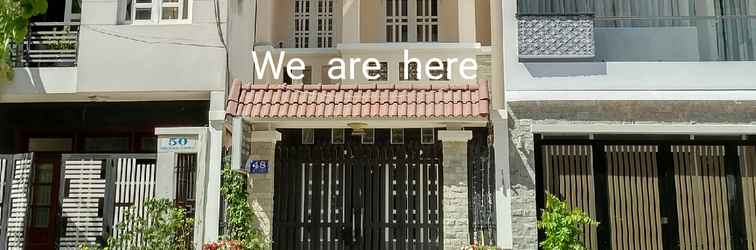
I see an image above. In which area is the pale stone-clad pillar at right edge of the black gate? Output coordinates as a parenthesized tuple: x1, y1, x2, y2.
(438, 130, 472, 250)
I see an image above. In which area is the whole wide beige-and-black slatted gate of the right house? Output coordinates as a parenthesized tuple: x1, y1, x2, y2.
(536, 141, 756, 250)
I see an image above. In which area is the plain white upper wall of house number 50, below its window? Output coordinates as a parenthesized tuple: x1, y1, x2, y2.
(77, 0, 226, 92)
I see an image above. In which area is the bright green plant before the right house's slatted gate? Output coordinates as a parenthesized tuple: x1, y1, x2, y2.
(538, 194, 599, 250)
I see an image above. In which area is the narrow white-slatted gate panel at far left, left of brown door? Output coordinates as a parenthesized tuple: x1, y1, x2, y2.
(5, 154, 33, 249)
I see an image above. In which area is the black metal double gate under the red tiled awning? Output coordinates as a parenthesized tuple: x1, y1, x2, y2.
(273, 130, 443, 249)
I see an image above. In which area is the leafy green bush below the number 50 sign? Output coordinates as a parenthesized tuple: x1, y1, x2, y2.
(100, 199, 194, 250)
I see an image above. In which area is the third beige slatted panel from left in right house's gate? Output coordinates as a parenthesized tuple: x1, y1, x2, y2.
(671, 145, 732, 249)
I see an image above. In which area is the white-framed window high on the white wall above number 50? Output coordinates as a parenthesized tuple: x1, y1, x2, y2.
(122, 0, 191, 24)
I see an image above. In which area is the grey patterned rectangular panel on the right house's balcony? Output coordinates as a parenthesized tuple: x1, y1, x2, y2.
(518, 15, 595, 59)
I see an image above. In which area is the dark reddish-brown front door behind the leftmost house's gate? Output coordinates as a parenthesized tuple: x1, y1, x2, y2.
(27, 153, 60, 250)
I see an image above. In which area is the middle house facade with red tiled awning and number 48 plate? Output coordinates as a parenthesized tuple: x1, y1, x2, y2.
(221, 0, 503, 249)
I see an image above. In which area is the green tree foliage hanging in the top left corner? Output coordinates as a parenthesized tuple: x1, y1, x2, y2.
(0, 0, 47, 83)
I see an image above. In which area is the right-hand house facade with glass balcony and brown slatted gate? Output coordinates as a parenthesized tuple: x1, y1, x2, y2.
(492, 0, 756, 249)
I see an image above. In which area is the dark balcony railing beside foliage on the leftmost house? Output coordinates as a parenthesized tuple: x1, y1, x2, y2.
(11, 22, 79, 67)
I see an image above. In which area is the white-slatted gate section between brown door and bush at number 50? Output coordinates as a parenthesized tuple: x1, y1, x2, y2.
(58, 154, 156, 249)
